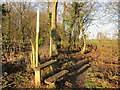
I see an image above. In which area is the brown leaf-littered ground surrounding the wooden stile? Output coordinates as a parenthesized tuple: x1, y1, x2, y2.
(0, 45, 120, 88)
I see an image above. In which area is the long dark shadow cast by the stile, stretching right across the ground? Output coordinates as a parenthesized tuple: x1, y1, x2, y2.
(43, 60, 90, 88)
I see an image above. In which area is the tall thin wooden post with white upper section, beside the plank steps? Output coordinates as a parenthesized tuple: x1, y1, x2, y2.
(35, 10, 41, 87)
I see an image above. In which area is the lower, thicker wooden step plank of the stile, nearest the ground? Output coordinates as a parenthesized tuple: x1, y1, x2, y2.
(45, 70, 69, 84)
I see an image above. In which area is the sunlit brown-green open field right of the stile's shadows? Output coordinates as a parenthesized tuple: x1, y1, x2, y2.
(85, 40, 120, 88)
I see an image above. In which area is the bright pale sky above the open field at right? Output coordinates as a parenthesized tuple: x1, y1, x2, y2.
(87, 3, 118, 39)
